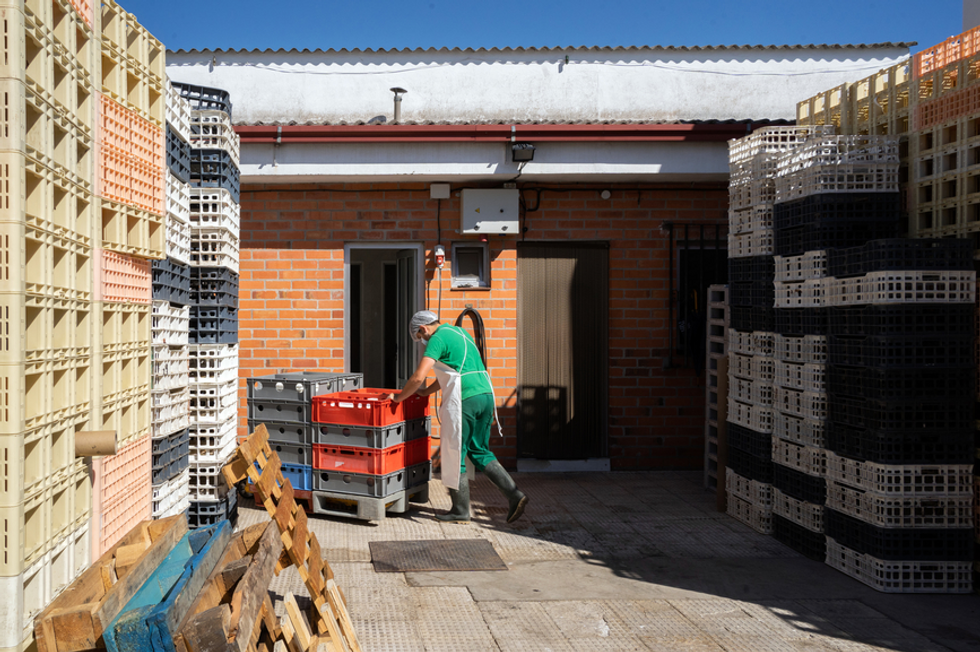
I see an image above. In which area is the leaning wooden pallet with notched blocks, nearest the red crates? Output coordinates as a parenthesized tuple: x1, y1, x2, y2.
(222, 425, 361, 652)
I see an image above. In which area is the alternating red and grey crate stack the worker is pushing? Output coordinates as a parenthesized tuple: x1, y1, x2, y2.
(311, 389, 432, 520)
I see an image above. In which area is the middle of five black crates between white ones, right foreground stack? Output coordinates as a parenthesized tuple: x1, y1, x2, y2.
(826, 364, 976, 401)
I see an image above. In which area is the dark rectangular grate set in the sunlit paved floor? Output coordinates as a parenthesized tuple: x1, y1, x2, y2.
(368, 539, 507, 573)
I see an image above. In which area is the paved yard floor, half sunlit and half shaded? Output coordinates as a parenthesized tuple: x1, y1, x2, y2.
(239, 472, 980, 652)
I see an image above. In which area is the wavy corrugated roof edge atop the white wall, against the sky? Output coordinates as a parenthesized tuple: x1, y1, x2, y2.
(168, 41, 917, 54)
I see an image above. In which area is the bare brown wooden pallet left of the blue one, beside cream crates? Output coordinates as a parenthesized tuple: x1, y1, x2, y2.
(34, 515, 187, 652)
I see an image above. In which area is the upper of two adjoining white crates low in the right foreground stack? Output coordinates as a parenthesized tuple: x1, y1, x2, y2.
(827, 451, 973, 497)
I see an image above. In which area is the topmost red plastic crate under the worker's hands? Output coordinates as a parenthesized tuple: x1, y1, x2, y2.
(313, 388, 429, 428)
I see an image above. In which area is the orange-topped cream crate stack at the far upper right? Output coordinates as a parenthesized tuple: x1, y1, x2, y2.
(909, 28, 980, 243)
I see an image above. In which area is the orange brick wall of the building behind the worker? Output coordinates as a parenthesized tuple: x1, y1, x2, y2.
(239, 184, 728, 469)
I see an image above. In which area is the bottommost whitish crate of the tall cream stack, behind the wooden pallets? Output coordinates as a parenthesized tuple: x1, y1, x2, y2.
(0, 521, 91, 649)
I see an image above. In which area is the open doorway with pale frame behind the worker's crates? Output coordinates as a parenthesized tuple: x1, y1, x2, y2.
(344, 244, 424, 389)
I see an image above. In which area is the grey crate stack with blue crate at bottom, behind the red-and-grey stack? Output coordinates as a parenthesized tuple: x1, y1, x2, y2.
(248, 371, 364, 499)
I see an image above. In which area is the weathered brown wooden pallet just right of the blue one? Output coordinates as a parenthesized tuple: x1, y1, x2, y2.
(174, 522, 283, 652)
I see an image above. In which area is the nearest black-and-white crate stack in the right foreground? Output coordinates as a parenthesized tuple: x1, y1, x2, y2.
(826, 240, 976, 593)
